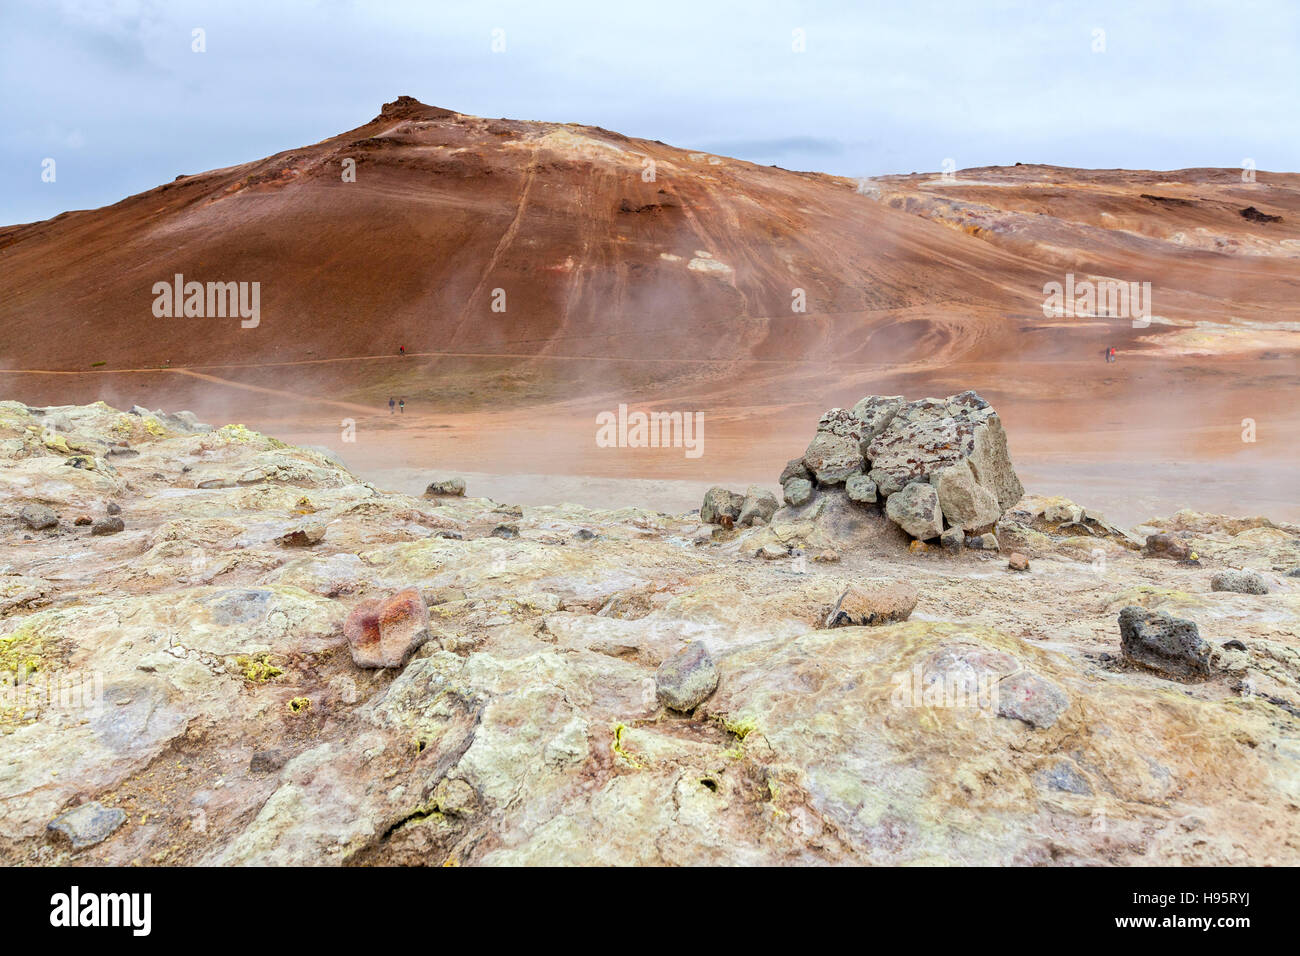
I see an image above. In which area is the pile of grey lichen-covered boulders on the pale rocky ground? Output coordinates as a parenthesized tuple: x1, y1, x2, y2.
(701, 392, 1024, 546)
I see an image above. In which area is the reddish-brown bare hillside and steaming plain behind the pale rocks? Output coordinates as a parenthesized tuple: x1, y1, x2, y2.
(0, 100, 1300, 519)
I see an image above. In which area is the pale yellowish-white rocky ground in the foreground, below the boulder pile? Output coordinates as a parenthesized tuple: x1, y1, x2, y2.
(0, 402, 1300, 865)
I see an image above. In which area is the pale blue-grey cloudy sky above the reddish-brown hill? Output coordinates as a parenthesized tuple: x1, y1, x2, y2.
(0, 0, 1300, 224)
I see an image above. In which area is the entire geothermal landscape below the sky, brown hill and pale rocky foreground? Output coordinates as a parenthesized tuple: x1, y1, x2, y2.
(0, 96, 1300, 866)
